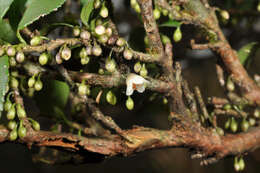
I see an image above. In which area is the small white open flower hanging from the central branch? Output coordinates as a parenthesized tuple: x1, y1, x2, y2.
(126, 73, 150, 96)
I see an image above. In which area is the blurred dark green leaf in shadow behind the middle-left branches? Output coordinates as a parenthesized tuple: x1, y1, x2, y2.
(36, 80, 70, 113)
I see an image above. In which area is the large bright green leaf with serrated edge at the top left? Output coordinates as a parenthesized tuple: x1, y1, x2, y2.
(18, 0, 66, 35)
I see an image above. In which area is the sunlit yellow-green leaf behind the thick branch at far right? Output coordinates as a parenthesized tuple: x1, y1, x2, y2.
(238, 42, 258, 65)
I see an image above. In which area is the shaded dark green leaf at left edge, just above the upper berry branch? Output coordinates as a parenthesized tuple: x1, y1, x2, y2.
(0, 20, 17, 43)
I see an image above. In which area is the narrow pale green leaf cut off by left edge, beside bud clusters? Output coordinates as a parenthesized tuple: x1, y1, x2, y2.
(0, 55, 9, 118)
